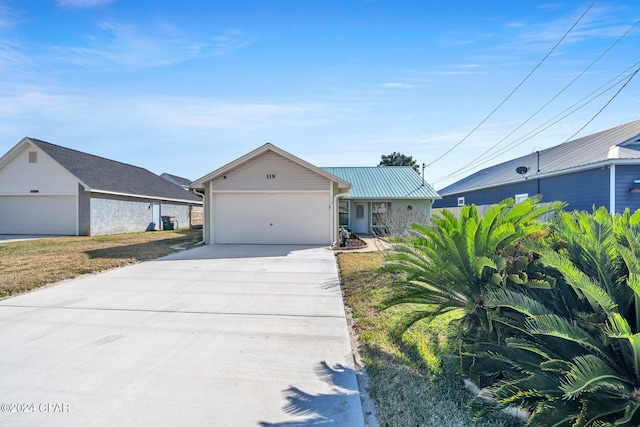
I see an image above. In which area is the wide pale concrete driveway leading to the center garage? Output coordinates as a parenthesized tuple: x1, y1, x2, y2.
(0, 245, 364, 427)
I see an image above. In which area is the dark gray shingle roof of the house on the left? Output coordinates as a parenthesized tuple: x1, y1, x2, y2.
(19, 137, 202, 203)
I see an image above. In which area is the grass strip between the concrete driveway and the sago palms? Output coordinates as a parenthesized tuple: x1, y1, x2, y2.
(338, 252, 521, 427)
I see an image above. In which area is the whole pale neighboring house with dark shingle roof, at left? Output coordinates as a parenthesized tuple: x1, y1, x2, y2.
(0, 138, 202, 235)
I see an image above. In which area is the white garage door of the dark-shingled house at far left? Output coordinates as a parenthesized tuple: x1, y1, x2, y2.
(0, 196, 76, 235)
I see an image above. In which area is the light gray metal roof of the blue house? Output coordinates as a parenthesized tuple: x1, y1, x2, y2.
(438, 120, 640, 195)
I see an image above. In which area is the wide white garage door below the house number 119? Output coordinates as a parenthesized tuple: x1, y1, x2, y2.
(214, 193, 331, 245)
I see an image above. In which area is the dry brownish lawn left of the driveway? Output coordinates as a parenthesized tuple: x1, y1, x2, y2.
(0, 230, 202, 298)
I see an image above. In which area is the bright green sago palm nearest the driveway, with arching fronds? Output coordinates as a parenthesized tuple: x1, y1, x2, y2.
(383, 198, 563, 340)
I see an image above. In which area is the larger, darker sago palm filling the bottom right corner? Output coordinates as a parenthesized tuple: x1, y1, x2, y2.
(466, 209, 640, 426)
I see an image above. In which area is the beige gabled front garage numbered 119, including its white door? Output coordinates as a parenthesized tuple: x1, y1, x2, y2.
(192, 144, 349, 245)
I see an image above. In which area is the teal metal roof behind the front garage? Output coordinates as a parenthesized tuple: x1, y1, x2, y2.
(321, 166, 441, 199)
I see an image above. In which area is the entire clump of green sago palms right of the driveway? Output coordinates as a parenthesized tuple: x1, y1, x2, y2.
(386, 200, 640, 426)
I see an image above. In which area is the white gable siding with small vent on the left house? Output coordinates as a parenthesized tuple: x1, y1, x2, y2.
(0, 144, 78, 196)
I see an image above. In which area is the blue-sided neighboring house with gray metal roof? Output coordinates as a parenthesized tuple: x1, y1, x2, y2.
(434, 120, 640, 212)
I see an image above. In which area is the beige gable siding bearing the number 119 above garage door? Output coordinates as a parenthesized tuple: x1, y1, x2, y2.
(213, 152, 330, 192)
